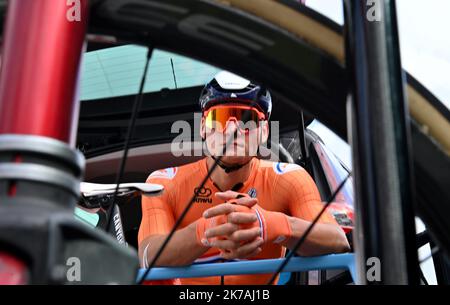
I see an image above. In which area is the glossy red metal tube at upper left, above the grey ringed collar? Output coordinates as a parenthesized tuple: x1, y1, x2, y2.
(0, 0, 88, 145)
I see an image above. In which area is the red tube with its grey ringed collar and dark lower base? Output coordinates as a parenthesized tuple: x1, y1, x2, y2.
(0, 0, 138, 284)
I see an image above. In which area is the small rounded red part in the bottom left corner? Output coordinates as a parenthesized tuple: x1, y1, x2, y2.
(0, 252, 28, 285)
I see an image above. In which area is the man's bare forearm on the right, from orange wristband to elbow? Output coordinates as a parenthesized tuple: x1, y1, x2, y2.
(284, 217, 350, 256)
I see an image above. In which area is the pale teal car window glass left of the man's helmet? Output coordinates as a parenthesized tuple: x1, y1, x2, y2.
(81, 45, 219, 101)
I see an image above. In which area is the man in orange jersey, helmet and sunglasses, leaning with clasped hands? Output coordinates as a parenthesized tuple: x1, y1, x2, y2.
(138, 71, 349, 284)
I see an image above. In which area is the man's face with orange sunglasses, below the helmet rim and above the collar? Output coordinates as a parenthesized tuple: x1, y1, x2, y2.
(200, 105, 268, 163)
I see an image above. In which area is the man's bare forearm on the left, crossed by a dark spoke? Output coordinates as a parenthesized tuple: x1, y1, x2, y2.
(139, 222, 208, 267)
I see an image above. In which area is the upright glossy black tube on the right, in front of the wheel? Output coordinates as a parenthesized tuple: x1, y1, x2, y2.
(344, 0, 419, 284)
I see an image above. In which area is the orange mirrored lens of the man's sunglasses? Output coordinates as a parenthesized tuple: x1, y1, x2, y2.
(205, 107, 259, 131)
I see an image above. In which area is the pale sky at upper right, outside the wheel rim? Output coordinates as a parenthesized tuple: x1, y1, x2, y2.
(306, 0, 450, 108)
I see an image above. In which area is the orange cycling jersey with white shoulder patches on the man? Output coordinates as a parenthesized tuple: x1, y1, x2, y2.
(138, 158, 337, 285)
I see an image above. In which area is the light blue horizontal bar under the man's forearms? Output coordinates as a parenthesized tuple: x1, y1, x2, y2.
(138, 253, 356, 281)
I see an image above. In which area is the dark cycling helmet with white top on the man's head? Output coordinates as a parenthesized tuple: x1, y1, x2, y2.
(199, 71, 272, 120)
